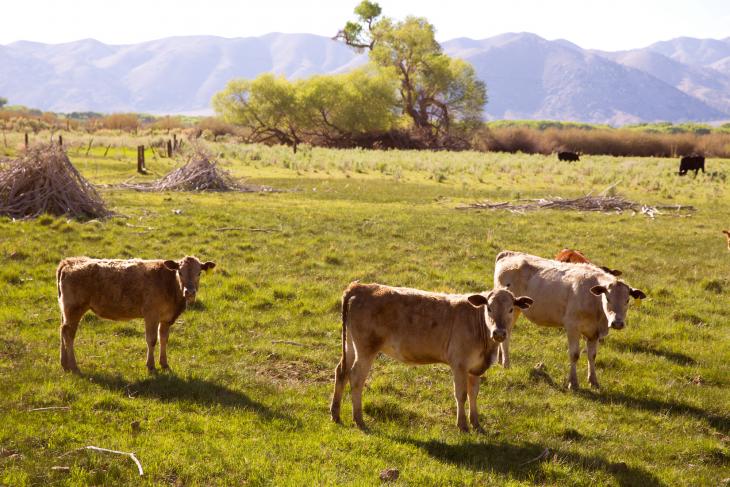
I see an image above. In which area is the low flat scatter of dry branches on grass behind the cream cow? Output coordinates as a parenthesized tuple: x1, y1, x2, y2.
(457, 195, 695, 218)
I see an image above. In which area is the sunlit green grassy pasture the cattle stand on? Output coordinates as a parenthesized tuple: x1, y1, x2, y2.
(0, 136, 730, 486)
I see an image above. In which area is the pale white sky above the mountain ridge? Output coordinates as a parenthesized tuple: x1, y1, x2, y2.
(0, 0, 730, 51)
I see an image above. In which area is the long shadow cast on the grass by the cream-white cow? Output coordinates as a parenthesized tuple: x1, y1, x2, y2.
(577, 389, 730, 435)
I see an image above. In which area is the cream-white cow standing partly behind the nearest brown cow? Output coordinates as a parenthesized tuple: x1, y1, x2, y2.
(494, 254, 646, 389)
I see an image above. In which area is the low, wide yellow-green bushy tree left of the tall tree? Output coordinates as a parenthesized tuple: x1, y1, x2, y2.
(213, 67, 397, 152)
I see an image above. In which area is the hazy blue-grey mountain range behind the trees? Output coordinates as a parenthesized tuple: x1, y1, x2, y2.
(0, 33, 730, 125)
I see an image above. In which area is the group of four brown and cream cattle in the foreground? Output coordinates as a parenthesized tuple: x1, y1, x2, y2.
(56, 249, 646, 431)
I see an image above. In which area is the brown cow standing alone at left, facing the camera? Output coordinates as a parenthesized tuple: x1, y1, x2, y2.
(56, 256, 215, 373)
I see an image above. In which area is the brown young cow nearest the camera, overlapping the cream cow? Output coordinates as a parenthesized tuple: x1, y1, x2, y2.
(330, 282, 532, 432)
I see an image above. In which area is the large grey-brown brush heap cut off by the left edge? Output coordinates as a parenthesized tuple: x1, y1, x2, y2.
(0, 144, 112, 219)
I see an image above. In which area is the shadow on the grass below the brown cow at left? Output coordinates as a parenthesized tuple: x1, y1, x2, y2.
(84, 372, 292, 420)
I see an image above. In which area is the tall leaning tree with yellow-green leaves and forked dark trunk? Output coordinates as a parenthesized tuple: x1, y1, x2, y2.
(335, 0, 487, 137)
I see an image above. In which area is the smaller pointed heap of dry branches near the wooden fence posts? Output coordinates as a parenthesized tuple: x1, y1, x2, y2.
(121, 148, 271, 192)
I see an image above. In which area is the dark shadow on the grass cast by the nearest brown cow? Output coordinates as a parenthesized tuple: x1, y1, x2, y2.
(394, 438, 664, 487)
